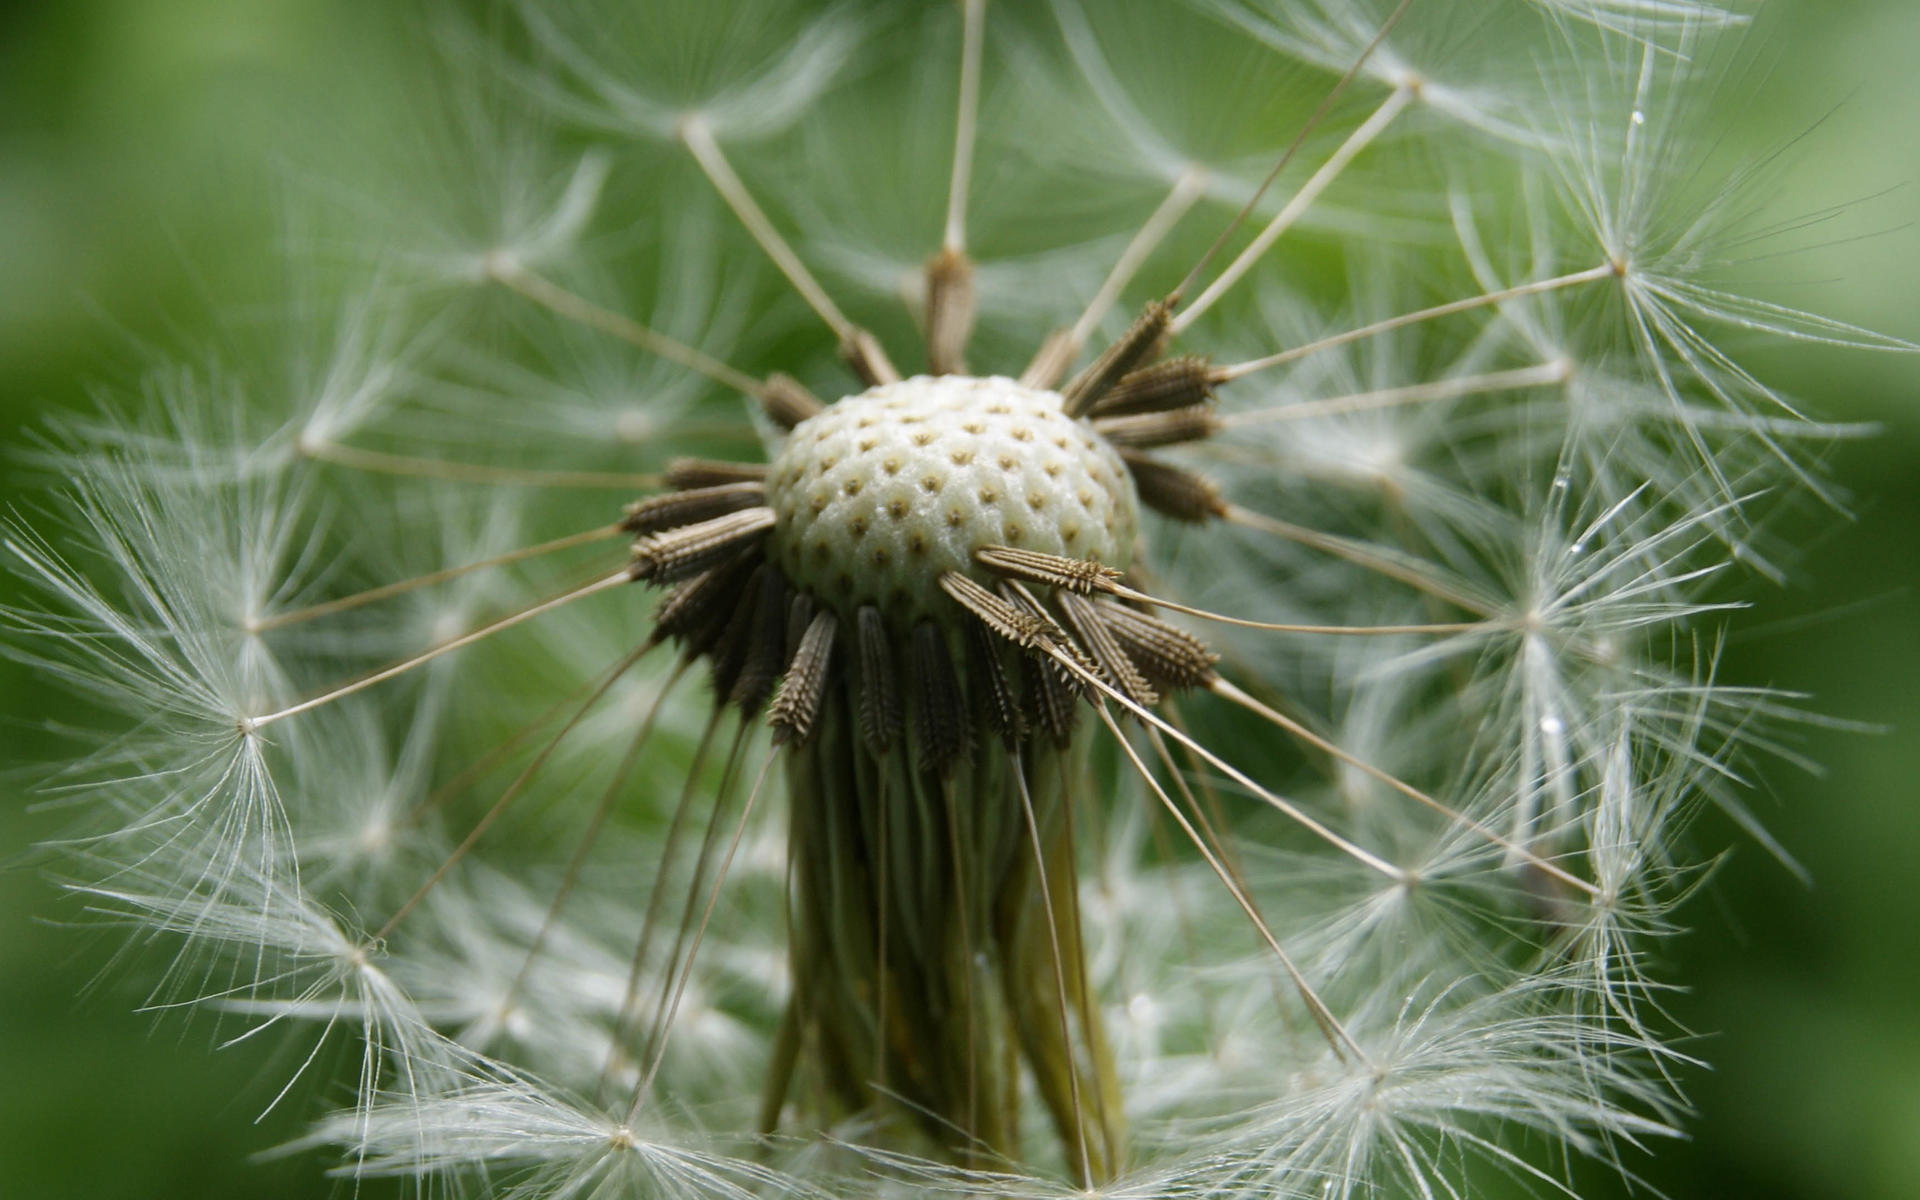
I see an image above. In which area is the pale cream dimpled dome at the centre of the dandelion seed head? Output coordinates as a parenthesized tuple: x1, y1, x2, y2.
(768, 374, 1139, 620)
